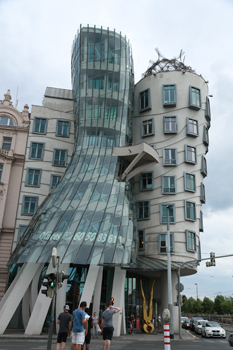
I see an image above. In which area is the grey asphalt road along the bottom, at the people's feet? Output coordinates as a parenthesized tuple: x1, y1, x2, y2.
(0, 334, 230, 350)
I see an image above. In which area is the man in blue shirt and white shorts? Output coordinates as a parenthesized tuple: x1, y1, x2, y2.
(71, 301, 87, 350)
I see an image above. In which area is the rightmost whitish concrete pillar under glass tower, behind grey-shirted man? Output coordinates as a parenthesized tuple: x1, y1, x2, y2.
(112, 267, 126, 337)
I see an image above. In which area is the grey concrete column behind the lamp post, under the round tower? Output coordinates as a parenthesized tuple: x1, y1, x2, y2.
(161, 271, 179, 333)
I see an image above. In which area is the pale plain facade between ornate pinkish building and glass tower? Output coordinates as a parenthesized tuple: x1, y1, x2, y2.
(13, 87, 74, 250)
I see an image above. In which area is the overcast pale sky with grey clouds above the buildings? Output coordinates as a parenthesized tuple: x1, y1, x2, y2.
(0, 0, 233, 299)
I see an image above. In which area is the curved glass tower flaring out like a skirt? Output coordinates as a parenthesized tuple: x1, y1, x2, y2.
(10, 26, 137, 265)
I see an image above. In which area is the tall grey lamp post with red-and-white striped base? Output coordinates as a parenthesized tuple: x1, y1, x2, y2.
(167, 205, 174, 339)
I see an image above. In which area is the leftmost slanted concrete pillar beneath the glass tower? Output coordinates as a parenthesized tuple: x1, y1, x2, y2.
(0, 263, 40, 334)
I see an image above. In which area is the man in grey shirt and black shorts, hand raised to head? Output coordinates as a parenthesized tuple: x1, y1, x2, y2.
(102, 302, 121, 350)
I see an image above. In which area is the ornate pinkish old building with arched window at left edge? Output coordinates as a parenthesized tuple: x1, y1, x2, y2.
(0, 90, 29, 300)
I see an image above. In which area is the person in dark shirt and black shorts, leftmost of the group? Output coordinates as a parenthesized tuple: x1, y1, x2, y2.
(56, 305, 71, 350)
